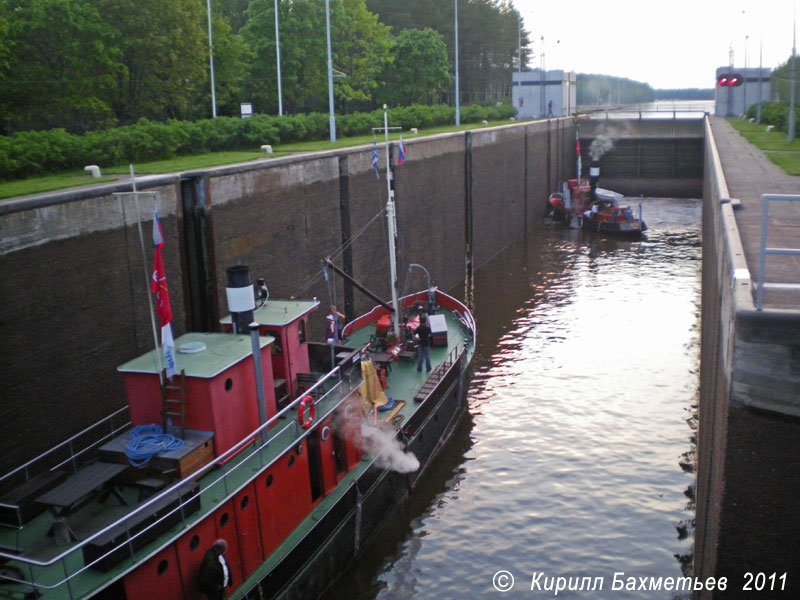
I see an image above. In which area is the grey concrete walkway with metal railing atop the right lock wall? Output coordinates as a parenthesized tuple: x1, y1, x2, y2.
(711, 117, 800, 309)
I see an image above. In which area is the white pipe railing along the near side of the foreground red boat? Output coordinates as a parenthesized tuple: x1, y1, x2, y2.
(0, 367, 361, 598)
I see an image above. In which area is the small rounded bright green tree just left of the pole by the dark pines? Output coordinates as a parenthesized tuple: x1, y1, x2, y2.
(383, 29, 453, 105)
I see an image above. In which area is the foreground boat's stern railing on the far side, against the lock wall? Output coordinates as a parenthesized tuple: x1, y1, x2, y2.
(0, 406, 131, 490)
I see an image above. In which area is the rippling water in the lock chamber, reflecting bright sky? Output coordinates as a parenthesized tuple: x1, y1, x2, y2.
(328, 200, 701, 599)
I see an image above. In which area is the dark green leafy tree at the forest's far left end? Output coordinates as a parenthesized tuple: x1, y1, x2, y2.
(0, 0, 120, 133)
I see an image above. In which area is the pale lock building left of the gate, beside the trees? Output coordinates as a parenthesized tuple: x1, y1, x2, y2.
(511, 69, 578, 119)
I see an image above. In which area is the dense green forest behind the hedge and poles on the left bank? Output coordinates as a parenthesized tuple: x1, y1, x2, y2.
(0, 0, 529, 135)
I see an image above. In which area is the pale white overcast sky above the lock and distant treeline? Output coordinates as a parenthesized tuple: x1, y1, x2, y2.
(513, 0, 796, 89)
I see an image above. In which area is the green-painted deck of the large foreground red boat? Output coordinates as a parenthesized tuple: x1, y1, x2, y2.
(0, 311, 471, 599)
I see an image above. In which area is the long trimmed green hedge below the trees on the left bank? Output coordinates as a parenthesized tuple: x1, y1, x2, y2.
(0, 104, 515, 180)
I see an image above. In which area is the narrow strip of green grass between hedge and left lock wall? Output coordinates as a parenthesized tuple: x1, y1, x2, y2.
(0, 120, 509, 199)
